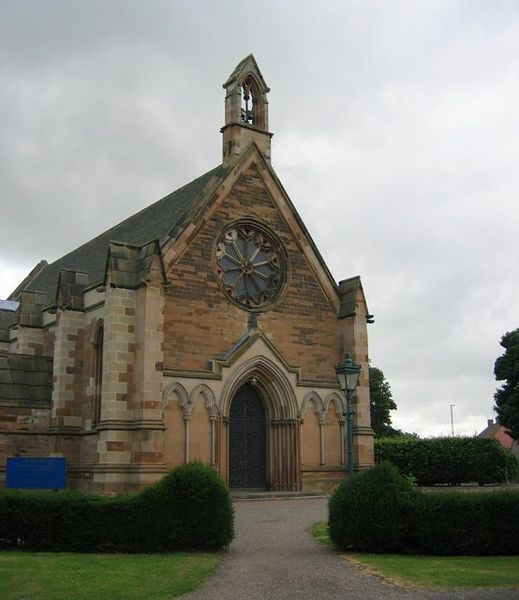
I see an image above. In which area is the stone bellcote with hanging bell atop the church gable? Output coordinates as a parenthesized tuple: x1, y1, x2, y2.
(221, 54, 272, 164)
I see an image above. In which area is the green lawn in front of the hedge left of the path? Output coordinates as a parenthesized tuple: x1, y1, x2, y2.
(0, 551, 219, 600)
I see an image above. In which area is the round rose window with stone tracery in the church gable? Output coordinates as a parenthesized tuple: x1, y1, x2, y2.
(216, 223, 286, 310)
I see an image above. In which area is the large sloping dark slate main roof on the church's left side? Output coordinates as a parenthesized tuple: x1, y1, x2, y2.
(20, 166, 228, 303)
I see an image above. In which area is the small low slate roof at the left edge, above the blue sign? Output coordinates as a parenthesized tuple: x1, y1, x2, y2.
(0, 353, 52, 405)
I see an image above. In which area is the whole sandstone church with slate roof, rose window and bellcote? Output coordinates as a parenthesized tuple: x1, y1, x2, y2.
(0, 55, 373, 493)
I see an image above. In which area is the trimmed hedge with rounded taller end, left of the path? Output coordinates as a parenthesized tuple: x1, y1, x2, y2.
(0, 463, 234, 552)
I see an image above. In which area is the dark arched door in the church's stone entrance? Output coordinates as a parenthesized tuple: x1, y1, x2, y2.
(229, 383, 266, 489)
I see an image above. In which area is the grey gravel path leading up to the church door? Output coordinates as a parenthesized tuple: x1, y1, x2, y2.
(182, 498, 519, 600)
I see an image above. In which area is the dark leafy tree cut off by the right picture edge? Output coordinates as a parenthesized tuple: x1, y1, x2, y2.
(494, 328, 519, 440)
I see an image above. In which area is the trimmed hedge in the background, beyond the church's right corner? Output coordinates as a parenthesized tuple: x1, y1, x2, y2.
(375, 437, 518, 485)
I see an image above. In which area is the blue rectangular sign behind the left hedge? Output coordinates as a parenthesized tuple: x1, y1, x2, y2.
(5, 457, 66, 490)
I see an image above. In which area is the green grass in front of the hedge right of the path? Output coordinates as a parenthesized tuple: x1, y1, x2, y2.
(311, 522, 519, 589)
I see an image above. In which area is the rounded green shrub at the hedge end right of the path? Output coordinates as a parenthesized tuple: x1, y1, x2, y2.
(328, 463, 416, 552)
